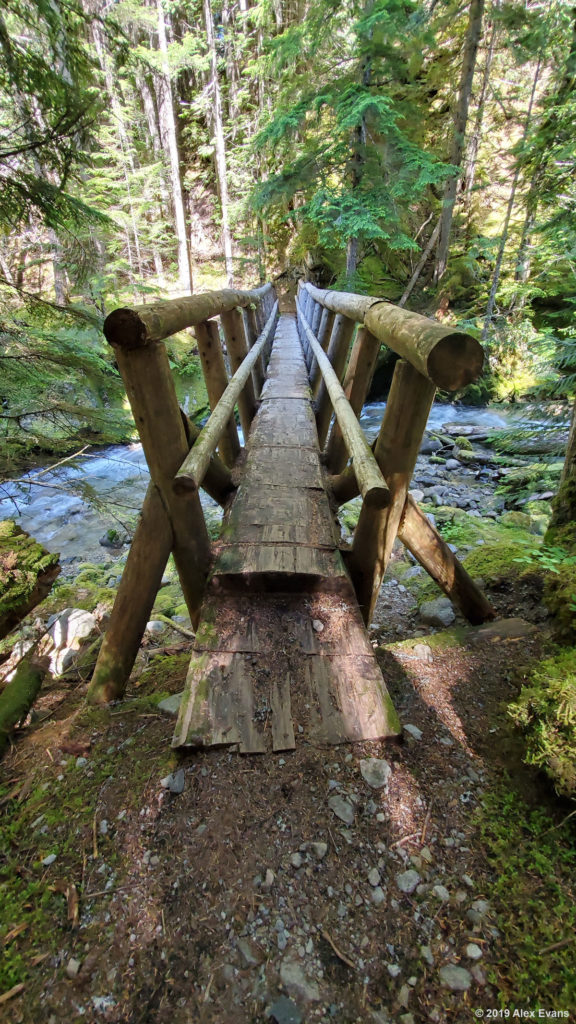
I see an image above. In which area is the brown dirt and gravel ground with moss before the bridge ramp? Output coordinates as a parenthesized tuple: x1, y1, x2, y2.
(0, 561, 576, 1024)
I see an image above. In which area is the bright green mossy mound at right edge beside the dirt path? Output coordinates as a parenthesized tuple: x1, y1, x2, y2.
(508, 647, 576, 798)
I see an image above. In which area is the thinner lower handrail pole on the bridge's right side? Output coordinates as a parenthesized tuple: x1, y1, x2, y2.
(296, 302, 388, 508)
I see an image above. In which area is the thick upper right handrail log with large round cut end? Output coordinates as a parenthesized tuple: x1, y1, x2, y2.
(302, 283, 484, 391)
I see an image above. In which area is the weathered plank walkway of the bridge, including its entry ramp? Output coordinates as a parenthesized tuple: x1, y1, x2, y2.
(173, 315, 401, 753)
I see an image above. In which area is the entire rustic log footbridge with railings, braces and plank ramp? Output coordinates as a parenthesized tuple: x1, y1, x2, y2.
(88, 283, 494, 753)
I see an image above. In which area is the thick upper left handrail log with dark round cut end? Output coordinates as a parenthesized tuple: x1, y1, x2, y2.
(104, 285, 274, 348)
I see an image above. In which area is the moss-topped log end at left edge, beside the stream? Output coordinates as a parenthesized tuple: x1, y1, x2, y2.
(0, 519, 60, 639)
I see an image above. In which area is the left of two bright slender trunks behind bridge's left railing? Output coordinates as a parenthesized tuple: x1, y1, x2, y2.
(157, 0, 194, 292)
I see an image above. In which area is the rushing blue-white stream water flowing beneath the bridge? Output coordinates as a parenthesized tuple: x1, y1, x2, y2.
(0, 401, 561, 574)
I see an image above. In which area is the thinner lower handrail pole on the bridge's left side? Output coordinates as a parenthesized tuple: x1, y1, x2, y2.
(172, 302, 278, 495)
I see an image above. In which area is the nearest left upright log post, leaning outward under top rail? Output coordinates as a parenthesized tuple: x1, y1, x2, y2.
(105, 310, 210, 624)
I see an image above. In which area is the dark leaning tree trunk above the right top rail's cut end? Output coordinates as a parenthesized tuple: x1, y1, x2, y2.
(435, 0, 484, 283)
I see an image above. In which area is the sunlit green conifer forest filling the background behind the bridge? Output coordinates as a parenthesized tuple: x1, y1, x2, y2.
(0, 0, 576, 470)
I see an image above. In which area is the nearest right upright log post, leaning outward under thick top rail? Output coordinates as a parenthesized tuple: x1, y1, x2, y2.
(348, 359, 436, 625)
